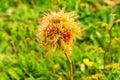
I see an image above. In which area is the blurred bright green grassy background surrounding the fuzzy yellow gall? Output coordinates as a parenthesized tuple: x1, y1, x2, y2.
(0, 0, 120, 80)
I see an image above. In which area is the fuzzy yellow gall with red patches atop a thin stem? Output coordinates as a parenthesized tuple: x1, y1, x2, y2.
(37, 10, 80, 54)
